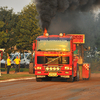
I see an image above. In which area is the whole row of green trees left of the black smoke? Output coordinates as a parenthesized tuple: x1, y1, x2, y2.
(0, 3, 42, 53)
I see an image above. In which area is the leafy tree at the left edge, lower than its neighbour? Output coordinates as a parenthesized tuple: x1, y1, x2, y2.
(0, 7, 17, 53)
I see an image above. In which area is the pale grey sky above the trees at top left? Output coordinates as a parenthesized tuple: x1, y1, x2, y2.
(0, 0, 32, 13)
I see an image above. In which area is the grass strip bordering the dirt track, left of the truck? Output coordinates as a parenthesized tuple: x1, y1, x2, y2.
(0, 74, 35, 80)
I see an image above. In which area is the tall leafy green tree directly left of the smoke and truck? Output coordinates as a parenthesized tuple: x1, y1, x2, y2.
(15, 3, 42, 51)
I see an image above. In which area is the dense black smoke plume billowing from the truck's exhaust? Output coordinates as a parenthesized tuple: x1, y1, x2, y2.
(35, 0, 100, 30)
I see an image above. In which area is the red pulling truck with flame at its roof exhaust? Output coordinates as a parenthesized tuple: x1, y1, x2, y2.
(33, 30, 89, 82)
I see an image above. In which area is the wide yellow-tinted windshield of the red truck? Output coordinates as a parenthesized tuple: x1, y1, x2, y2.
(37, 40, 70, 51)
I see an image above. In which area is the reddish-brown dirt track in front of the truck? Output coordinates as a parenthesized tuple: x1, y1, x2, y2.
(0, 74, 100, 100)
